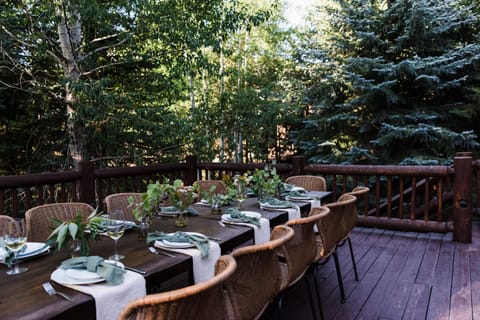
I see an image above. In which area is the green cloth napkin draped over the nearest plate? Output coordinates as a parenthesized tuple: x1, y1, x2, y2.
(60, 256, 125, 285)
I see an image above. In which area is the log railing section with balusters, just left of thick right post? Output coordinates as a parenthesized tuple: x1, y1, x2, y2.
(304, 164, 454, 232)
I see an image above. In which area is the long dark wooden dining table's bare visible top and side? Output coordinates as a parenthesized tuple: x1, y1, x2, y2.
(0, 194, 330, 320)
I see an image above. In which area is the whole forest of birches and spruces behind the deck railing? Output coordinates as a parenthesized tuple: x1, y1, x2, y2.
(0, 0, 480, 175)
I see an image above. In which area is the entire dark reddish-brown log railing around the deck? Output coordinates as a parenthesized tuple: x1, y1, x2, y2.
(0, 153, 480, 242)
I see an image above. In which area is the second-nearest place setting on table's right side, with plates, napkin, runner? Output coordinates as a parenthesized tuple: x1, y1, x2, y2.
(147, 231, 221, 283)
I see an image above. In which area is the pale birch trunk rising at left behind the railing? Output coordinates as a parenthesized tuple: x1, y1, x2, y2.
(56, 1, 85, 169)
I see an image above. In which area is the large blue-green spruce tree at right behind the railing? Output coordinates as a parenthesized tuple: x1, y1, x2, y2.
(295, 0, 480, 164)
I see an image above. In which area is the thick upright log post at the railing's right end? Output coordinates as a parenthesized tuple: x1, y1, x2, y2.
(453, 152, 473, 243)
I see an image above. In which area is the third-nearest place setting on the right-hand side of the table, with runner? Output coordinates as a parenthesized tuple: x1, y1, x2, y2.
(221, 208, 270, 244)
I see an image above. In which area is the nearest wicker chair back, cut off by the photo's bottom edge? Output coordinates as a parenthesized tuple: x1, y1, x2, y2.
(118, 255, 237, 320)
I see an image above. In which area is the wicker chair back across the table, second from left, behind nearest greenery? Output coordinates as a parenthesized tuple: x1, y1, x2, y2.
(25, 202, 94, 242)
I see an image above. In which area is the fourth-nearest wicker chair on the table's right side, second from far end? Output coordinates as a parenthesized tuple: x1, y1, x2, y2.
(310, 194, 357, 303)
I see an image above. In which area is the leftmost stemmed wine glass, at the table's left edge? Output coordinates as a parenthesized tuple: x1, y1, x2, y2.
(3, 219, 28, 275)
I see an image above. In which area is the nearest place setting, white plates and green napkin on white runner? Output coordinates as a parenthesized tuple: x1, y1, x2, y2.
(50, 256, 146, 320)
